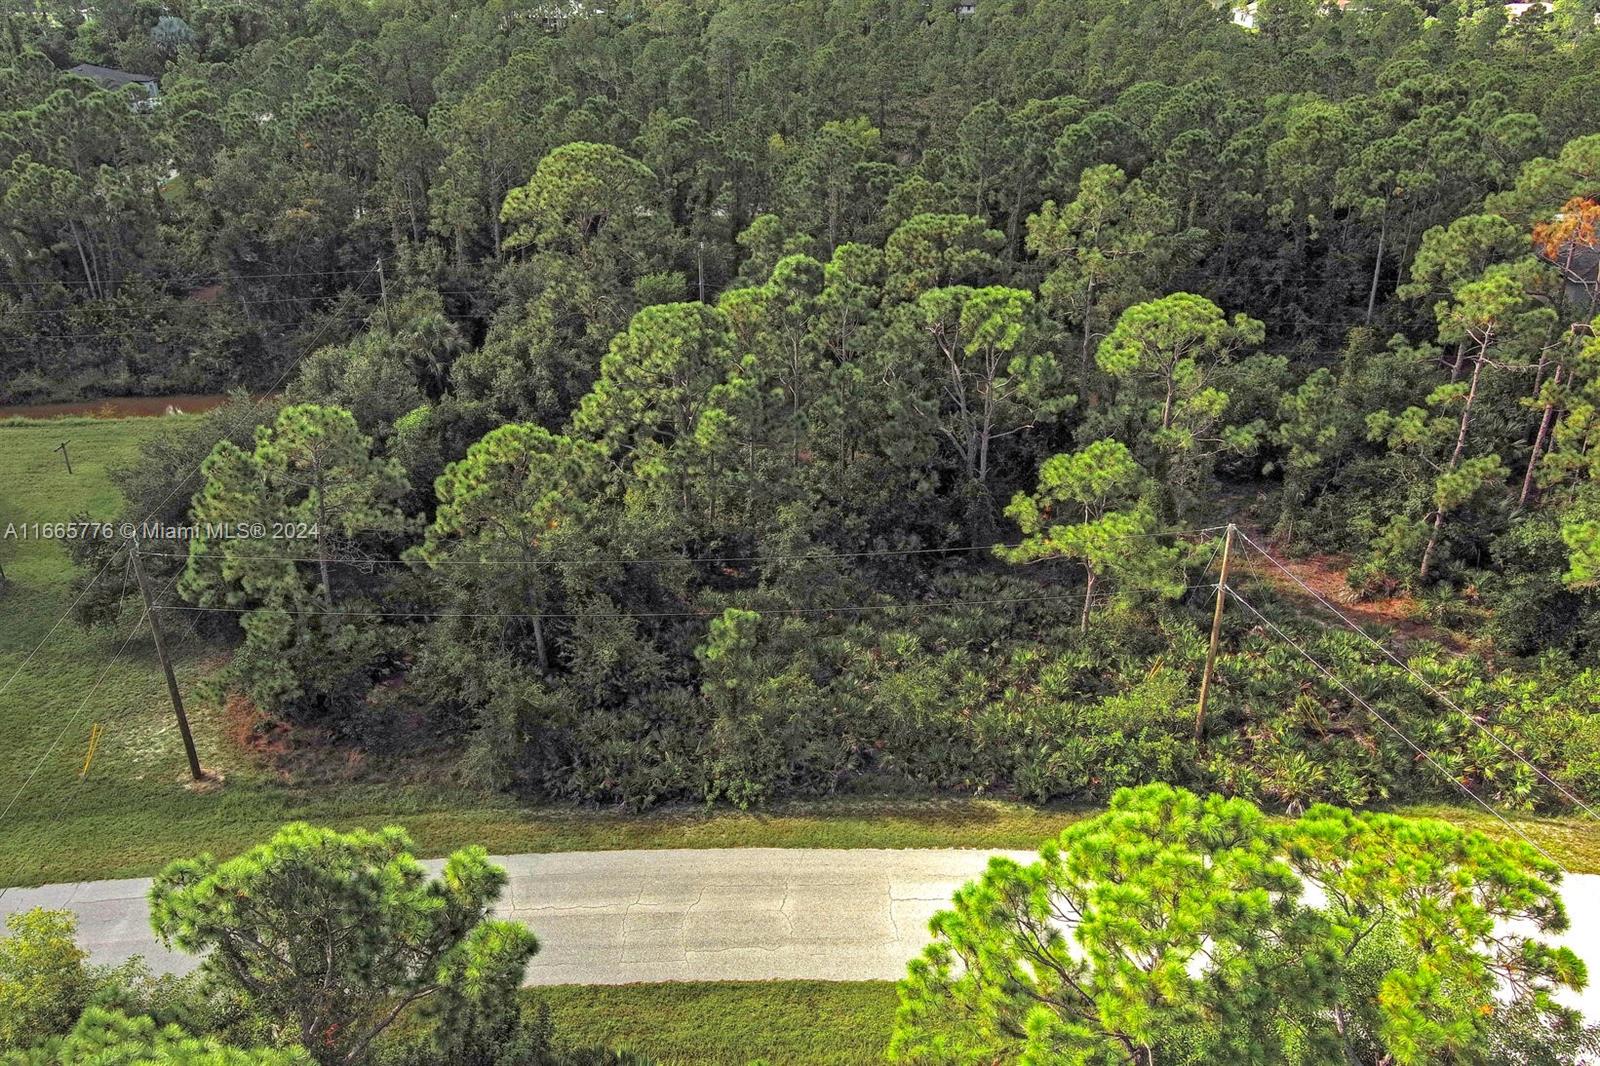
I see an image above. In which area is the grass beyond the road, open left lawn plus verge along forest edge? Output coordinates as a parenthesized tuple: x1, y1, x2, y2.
(0, 418, 1600, 885)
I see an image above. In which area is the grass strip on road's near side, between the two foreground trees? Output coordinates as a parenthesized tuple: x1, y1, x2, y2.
(526, 981, 894, 1066)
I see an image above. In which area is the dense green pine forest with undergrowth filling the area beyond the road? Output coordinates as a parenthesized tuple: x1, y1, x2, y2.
(0, 0, 1600, 807)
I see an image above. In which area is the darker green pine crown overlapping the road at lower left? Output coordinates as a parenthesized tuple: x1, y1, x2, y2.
(150, 823, 538, 1066)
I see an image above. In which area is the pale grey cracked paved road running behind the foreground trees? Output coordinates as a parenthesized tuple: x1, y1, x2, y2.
(0, 848, 1600, 1020)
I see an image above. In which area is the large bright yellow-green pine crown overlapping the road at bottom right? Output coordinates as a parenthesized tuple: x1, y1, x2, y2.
(890, 784, 1586, 1066)
